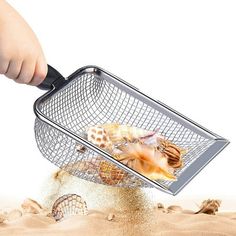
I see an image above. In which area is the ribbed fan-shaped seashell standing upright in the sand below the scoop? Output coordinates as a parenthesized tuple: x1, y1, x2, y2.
(52, 194, 88, 221)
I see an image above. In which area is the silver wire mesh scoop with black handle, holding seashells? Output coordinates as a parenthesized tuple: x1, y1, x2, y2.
(34, 66, 229, 195)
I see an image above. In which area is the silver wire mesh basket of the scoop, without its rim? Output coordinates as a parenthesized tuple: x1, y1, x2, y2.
(35, 73, 214, 190)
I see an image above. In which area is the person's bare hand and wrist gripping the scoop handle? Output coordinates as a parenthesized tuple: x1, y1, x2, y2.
(0, 0, 47, 85)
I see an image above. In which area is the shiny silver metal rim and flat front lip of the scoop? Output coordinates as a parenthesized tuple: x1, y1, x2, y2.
(34, 66, 229, 195)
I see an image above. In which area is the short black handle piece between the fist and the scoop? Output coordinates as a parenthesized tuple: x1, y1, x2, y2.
(37, 65, 64, 90)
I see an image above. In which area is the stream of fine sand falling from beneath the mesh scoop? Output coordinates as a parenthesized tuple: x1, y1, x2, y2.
(42, 170, 152, 213)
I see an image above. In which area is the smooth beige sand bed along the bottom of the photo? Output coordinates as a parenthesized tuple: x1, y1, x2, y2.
(0, 209, 236, 236)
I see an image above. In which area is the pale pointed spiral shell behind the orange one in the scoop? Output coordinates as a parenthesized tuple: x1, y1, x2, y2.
(101, 123, 155, 144)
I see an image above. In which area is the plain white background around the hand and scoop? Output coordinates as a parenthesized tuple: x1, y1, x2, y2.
(0, 0, 236, 210)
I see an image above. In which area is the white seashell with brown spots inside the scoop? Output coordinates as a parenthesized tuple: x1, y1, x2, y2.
(87, 126, 112, 149)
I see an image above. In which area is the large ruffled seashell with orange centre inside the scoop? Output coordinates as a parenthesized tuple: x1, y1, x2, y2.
(115, 143, 176, 181)
